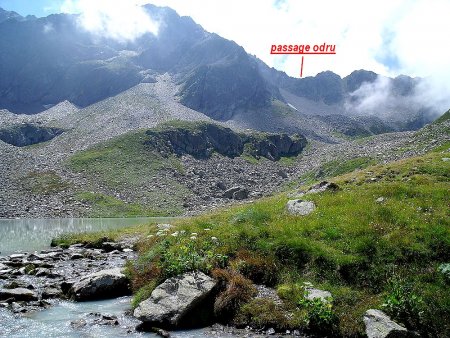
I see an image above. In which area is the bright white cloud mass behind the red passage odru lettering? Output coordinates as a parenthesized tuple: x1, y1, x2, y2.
(153, 0, 450, 111)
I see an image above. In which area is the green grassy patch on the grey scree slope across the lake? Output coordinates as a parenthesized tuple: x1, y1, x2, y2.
(67, 131, 190, 217)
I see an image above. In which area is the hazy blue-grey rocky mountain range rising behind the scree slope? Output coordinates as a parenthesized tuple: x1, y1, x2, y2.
(0, 5, 440, 135)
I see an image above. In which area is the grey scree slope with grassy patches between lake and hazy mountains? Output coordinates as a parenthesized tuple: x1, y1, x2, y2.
(0, 99, 448, 217)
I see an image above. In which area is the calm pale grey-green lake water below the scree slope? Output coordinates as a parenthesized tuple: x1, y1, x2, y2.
(0, 217, 173, 255)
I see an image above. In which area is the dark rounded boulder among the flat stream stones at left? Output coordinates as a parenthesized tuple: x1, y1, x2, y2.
(69, 268, 130, 301)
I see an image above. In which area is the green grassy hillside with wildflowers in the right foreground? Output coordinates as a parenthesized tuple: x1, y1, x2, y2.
(58, 144, 450, 337)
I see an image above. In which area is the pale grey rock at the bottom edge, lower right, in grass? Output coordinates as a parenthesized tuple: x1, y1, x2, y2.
(363, 309, 409, 338)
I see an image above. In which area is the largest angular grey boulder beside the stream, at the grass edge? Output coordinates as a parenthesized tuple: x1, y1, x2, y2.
(134, 272, 217, 328)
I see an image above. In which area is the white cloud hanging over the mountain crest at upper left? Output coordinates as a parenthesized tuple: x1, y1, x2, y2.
(61, 0, 159, 42)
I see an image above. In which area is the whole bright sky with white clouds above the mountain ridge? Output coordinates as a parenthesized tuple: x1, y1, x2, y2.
(0, 0, 450, 83)
